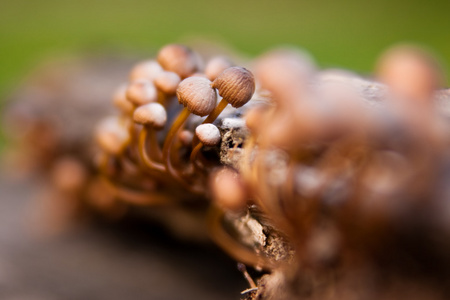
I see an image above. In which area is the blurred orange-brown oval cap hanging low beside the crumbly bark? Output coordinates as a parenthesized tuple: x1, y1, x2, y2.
(211, 168, 247, 211)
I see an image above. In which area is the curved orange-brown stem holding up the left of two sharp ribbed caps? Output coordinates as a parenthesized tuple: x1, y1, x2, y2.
(163, 108, 202, 194)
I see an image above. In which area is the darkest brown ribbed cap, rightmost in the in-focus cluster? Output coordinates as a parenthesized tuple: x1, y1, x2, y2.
(212, 67, 255, 108)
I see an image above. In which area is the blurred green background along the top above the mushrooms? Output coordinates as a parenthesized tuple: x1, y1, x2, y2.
(0, 0, 450, 148)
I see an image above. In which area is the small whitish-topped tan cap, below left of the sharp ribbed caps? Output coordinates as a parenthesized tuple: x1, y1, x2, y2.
(133, 103, 167, 129)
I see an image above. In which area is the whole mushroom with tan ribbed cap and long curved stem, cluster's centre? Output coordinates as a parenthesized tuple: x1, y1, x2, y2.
(163, 77, 217, 191)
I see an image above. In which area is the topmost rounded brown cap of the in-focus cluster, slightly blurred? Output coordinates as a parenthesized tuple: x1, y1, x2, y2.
(158, 44, 198, 78)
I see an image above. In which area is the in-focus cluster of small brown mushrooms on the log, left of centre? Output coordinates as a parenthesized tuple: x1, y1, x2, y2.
(96, 44, 255, 211)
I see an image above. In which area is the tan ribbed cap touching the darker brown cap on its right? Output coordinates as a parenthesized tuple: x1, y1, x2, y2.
(177, 77, 217, 117)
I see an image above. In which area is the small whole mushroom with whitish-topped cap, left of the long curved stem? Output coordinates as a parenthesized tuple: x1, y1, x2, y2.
(133, 103, 167, 171)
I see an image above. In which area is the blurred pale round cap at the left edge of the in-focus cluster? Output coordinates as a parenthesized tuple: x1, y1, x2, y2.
(96, 117, 130, 155)
